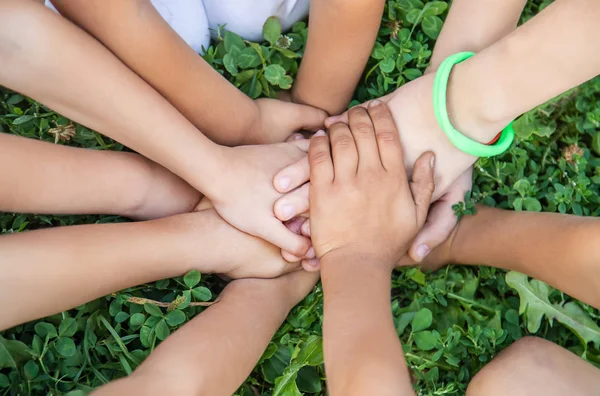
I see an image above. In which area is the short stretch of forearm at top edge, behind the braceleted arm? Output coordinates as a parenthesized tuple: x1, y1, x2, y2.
(430, 0, 527, 69)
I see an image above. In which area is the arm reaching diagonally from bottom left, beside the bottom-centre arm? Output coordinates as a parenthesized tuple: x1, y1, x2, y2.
(94, 271, 318, 396)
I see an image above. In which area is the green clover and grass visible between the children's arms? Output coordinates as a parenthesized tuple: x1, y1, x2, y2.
(0, 0, 600, 396)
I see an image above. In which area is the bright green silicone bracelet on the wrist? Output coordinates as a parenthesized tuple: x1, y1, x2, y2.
(433, 52, 515, 157)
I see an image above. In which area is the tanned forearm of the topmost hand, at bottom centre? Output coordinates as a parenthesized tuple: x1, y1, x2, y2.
(321, 256, 414, 396)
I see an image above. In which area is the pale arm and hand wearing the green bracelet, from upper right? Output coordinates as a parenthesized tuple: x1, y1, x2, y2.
(274, 0, 600, 238)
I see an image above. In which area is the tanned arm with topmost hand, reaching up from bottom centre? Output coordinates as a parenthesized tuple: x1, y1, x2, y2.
(309, 102, 434, 396)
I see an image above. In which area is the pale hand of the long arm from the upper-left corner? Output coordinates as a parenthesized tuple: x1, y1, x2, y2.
(209, 140, 314, 259)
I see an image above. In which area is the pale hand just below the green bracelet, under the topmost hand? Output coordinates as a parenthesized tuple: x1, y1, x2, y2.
(274, 74, 494, 261)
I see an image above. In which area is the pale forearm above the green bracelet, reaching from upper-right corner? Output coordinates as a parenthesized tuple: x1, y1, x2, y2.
(448, 0, 600, 142)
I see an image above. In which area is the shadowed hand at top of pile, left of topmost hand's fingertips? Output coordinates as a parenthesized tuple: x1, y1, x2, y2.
(248, 98, 327, 144)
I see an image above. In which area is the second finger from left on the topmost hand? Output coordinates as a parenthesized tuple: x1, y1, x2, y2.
(329, 123, 358, 180)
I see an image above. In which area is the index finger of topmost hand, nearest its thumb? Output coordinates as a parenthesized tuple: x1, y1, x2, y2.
(368, 100, 406, 175)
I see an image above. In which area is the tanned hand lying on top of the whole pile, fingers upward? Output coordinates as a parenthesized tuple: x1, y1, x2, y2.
(309, 102, 434, 269)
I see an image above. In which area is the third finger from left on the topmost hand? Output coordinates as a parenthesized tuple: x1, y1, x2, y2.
(348, 106, 382, 172)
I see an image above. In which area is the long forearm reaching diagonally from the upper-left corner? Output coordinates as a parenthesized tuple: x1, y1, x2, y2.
(0, 0, 225, 193)
